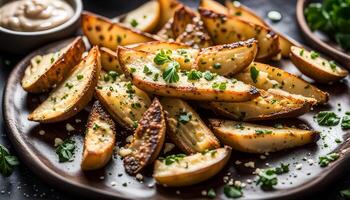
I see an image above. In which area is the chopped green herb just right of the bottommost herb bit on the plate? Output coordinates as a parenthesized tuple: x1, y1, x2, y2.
(256, 168, 278, 189)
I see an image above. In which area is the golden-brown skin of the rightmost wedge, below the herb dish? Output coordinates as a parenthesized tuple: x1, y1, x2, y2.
(290, 46, 349, 83)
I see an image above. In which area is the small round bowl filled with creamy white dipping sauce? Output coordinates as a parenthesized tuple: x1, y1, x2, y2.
(0, 0, 83, 54)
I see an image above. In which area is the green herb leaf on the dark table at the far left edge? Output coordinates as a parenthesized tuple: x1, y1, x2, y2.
(0, 144, 19, 176)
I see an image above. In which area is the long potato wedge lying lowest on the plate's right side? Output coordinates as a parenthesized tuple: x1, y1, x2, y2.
(209, 119, 319, 153)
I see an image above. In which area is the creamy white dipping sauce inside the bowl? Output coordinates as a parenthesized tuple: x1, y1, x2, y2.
(0, 0, 74, 32)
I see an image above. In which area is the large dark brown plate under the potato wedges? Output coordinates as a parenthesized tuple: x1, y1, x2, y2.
(3, 36, 350, 199)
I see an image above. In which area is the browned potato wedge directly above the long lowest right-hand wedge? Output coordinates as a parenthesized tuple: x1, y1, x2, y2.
(209, 90, 316, 121)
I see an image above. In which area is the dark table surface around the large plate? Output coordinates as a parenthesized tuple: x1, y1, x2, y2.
(0, 0, 350, 200)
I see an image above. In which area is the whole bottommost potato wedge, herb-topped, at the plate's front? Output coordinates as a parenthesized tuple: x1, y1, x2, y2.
(153, 146, 231, 187)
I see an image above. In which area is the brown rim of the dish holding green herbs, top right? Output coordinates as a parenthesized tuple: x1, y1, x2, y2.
(296, 0, 350, 69)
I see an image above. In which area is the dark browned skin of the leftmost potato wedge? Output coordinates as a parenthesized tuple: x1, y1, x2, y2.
(22, 36, 85, 93)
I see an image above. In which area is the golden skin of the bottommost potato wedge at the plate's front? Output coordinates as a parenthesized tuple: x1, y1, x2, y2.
(153, 146, 232, 187)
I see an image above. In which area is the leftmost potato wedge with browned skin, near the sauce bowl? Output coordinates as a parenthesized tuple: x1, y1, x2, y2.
(22, 36, 85, 93)
